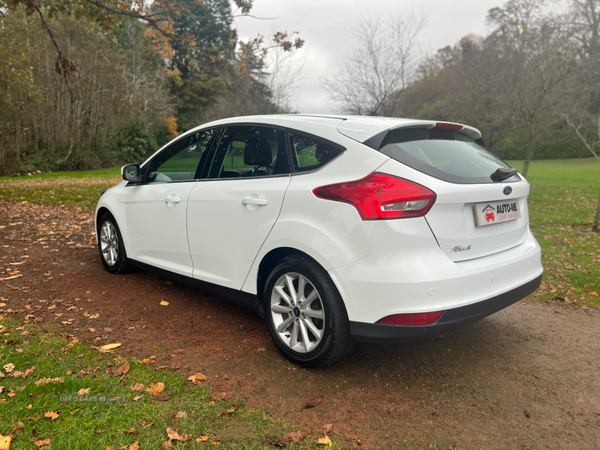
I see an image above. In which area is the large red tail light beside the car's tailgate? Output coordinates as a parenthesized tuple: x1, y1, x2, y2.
(313, 172, 435, 220)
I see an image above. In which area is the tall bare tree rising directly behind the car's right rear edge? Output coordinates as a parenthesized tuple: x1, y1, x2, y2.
(486, 0, 577, 176)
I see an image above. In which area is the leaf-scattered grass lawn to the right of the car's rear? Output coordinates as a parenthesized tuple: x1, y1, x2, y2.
(508, 158, 600, 307)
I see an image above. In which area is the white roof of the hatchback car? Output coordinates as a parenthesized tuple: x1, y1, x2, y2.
(186, 114, 481, 148)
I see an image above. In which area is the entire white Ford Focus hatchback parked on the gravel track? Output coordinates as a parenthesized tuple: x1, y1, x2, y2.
(96, 115, 543, 367)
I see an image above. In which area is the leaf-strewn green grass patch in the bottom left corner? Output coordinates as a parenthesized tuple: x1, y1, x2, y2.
(0, 316, 328, 450)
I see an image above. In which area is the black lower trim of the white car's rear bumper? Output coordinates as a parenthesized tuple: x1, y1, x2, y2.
(350, 274, 542, 343)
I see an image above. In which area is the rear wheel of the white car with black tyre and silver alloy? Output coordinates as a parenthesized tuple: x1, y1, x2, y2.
(263, 255, 354, 367)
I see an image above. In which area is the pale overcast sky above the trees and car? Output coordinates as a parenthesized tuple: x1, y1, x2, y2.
(235, 0, 505, 114)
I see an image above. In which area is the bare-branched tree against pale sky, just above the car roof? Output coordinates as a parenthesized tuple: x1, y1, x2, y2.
(322, 13, 426, 115)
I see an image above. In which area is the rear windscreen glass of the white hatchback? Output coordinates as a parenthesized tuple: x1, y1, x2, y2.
(379, 128, 510, 184)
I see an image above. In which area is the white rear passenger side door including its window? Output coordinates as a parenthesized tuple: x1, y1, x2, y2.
(187, 125, 290, 289)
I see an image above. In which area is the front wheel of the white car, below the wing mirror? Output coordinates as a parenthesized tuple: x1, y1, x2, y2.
(97, 212, 131, 273)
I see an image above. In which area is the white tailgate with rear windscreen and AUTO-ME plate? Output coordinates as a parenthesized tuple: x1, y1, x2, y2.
(380, 126, 529, 261)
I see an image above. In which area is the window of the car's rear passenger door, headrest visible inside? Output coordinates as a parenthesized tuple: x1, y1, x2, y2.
(209, 126, 290, 178)
